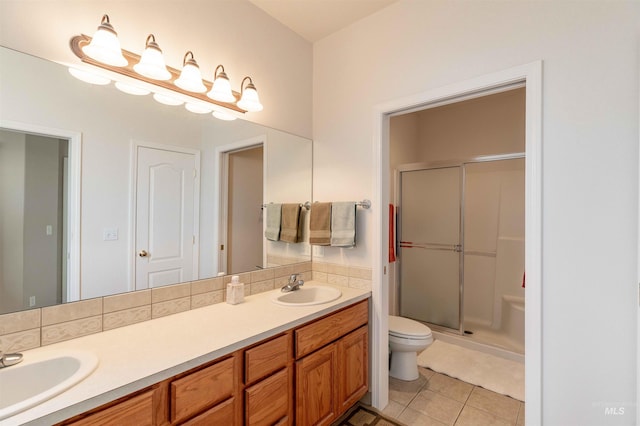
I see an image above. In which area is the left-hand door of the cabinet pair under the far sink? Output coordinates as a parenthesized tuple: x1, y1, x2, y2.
(296, 345, 338, 426)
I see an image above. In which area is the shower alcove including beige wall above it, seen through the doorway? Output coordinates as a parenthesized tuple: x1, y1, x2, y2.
(390, 87, 525, 355)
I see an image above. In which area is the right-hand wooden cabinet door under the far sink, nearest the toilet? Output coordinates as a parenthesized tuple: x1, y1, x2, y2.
(338, 326, 369, 414)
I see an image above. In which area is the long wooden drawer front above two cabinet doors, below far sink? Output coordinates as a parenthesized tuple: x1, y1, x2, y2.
(295, 300, 369, 359)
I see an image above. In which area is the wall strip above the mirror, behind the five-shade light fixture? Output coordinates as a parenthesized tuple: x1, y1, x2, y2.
(0, 0, 312, 137)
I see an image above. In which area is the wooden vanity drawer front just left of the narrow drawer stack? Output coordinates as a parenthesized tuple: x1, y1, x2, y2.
(170, 358, 235, 422)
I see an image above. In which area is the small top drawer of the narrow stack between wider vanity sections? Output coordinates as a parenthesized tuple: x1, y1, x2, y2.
(244, 334, 291, 384)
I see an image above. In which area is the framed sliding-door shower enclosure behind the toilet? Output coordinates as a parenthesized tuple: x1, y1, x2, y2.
(398, 153, 524, 352)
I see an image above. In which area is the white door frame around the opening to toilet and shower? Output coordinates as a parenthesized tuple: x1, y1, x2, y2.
(371, 61, 542, 424)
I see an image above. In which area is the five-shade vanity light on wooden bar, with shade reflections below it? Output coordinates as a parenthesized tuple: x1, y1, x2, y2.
(70, 15, 263, 120)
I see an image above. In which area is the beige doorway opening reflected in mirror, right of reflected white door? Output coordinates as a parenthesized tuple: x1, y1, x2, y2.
(226, 145, 265, 273)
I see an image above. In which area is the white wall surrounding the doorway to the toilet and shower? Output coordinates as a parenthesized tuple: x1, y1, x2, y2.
(313, 0, 640, 425)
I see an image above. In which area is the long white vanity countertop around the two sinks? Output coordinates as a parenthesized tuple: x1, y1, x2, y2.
(0, 282, 371, 426)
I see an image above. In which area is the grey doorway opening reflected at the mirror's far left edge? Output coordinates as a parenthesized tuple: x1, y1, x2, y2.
(0, 129, 69, 313)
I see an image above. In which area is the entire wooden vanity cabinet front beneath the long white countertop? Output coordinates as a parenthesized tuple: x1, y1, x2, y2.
(57, 300, 369, 426)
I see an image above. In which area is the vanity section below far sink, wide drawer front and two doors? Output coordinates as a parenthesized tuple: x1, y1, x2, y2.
(295, 300, 369, 426)
